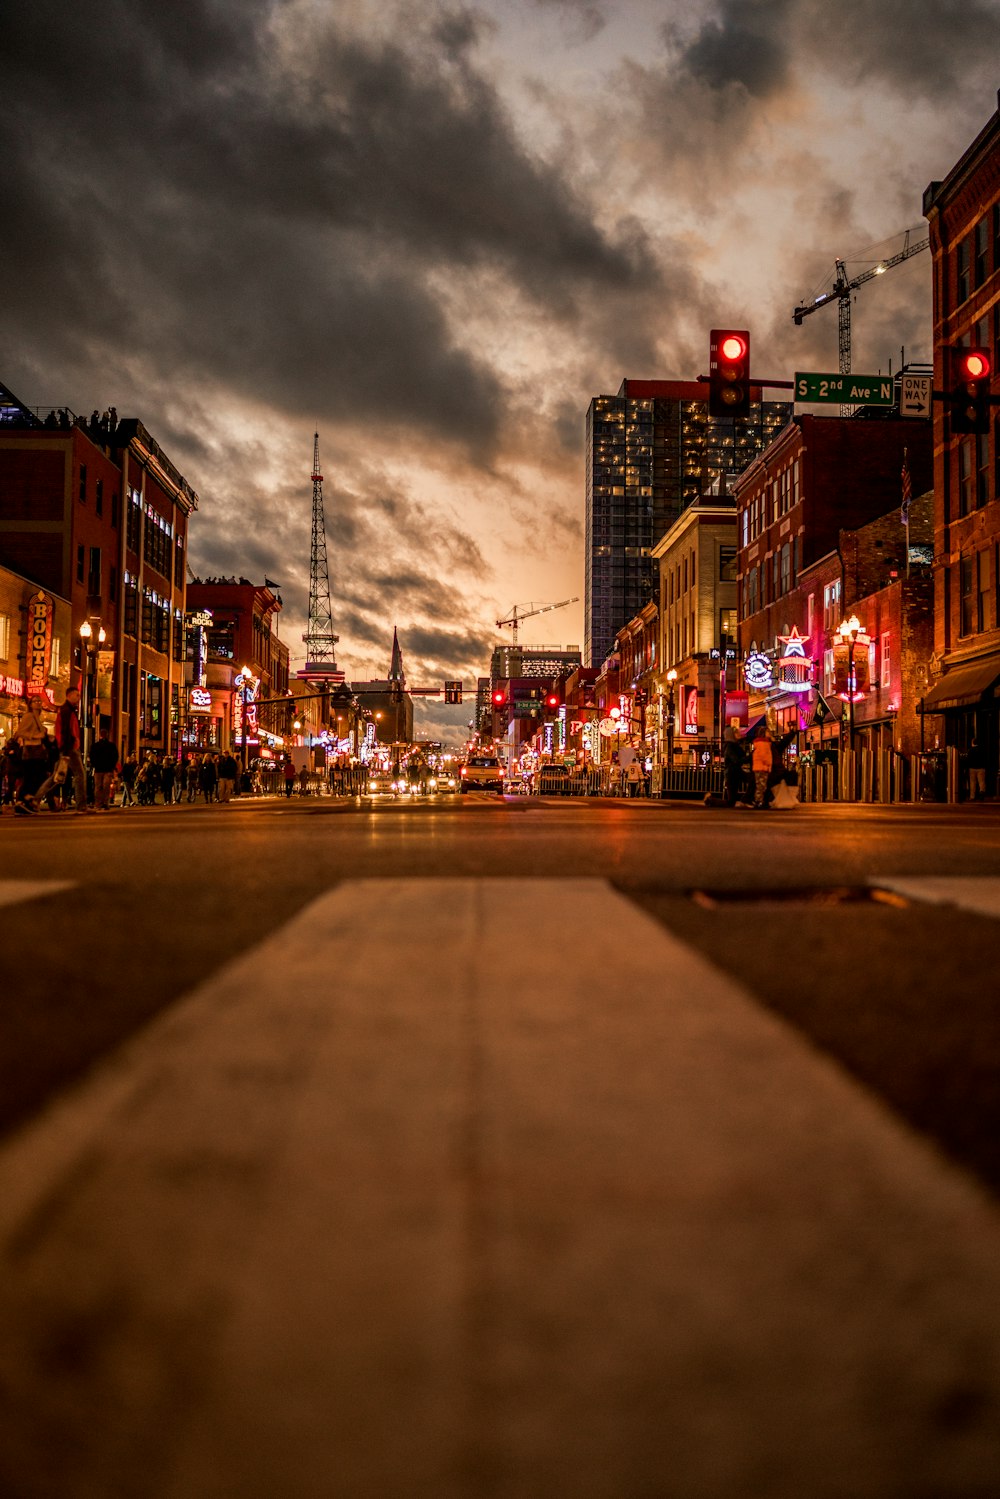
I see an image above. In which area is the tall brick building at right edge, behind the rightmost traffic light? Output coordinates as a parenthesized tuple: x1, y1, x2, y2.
(924, 96, 1000, 791)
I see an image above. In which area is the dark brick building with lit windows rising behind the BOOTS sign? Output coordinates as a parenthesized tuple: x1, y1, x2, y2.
(0, 387, 198, 754)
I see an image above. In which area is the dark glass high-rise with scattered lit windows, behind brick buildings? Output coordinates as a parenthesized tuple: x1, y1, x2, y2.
(583, 379, 792, 666)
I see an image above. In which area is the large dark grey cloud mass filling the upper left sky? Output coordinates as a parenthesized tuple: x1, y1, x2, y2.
(0, 0, 654, 457)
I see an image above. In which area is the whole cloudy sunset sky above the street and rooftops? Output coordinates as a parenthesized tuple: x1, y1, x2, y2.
(0, 0, 1000, 732)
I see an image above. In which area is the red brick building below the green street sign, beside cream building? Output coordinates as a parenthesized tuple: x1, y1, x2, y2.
(735, 415, 933, 748)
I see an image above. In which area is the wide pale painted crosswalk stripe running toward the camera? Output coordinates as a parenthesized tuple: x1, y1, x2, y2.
(0, 880, 1000, 1499)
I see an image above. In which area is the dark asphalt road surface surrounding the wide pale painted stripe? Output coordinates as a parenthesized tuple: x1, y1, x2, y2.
(0, 796, 1000, 1190)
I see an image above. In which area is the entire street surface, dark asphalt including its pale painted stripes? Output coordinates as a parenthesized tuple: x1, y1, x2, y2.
(0, 796, 1000, 1499)
